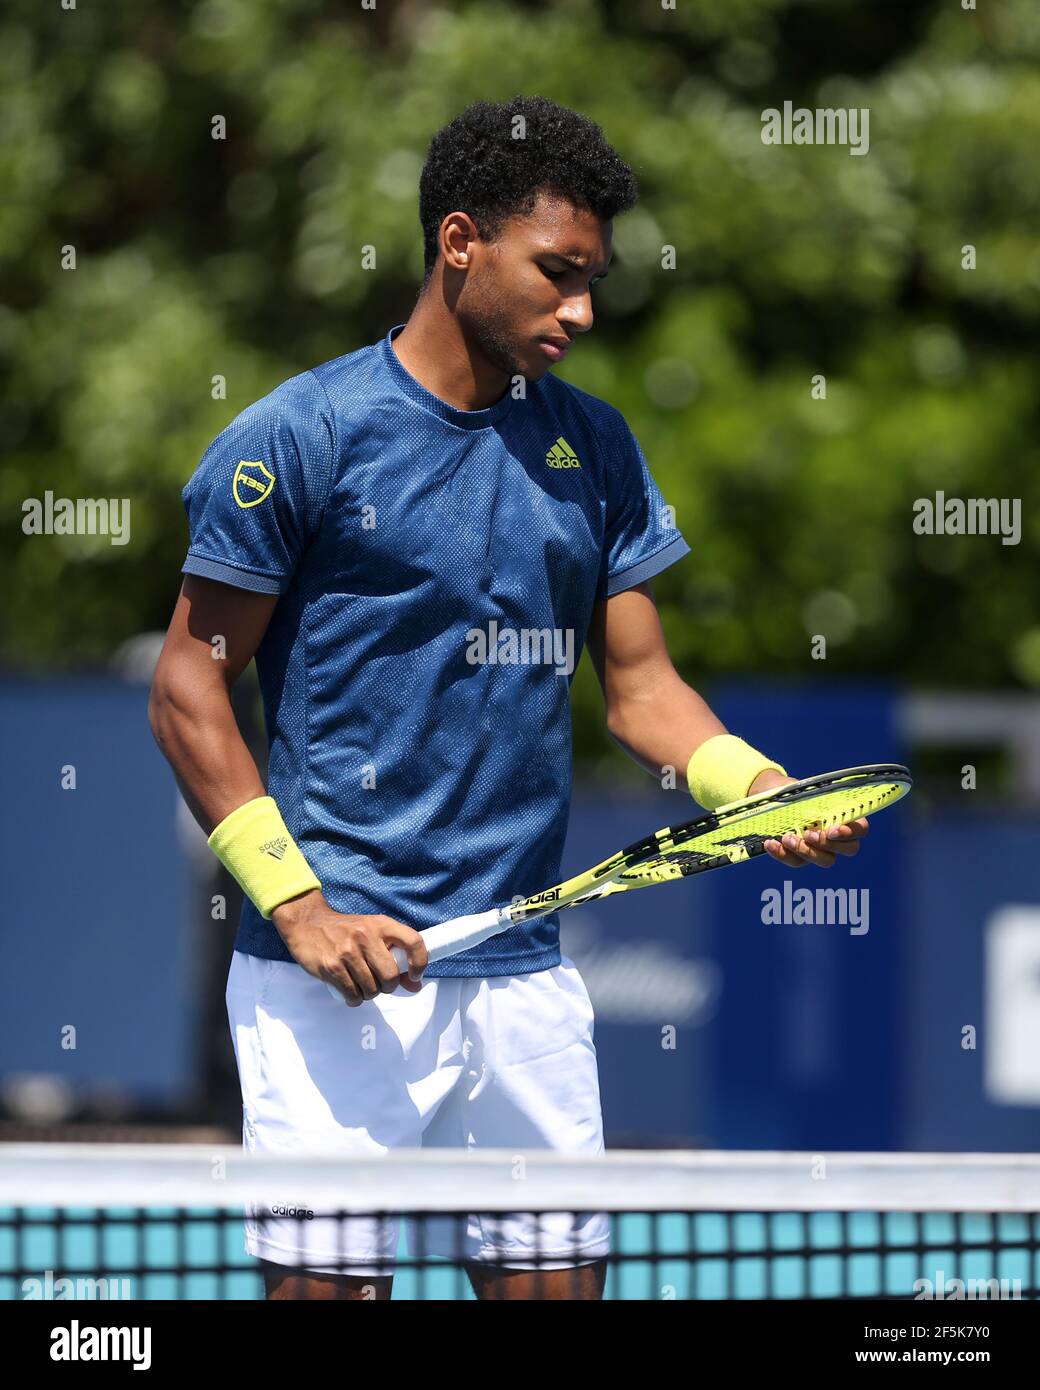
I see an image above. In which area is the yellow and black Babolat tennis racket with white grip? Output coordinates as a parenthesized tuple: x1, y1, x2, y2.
(380, 763, 912, 973)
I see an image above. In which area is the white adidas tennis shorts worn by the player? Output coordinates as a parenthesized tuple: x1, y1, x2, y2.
(227, 951, 609, 1276)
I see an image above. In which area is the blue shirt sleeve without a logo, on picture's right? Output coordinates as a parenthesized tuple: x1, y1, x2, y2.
(598, 410, 690, 599)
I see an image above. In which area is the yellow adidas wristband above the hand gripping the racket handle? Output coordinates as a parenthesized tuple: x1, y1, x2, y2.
(207, 796, 321, 917)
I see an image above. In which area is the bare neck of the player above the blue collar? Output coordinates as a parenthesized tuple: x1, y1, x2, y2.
(392, 291, 509, 410)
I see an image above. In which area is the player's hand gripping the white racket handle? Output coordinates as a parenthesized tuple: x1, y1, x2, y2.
(271, 890, 430, 1008)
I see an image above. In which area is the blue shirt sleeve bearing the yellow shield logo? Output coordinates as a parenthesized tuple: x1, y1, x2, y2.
(182, 373, 335, 594)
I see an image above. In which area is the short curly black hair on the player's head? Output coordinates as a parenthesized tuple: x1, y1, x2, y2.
(419, 96, 638, 284)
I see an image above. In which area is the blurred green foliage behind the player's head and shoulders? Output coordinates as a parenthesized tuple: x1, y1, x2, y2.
(0, 0, 1040, 755)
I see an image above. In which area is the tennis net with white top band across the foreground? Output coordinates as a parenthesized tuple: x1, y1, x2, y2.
(0, 1144, 1040, 1300)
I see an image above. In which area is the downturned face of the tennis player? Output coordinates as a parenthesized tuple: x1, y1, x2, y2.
(455, 193, 613, 381)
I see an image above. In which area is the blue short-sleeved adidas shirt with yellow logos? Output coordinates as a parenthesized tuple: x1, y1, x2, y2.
(184, 325, 690, 977)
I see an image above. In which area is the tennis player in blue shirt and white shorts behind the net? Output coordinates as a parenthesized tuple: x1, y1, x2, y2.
(150, 97, 866, 1300)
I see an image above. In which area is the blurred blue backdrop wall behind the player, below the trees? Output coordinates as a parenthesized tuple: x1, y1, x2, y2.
(0, 680, 1040, 1151)
